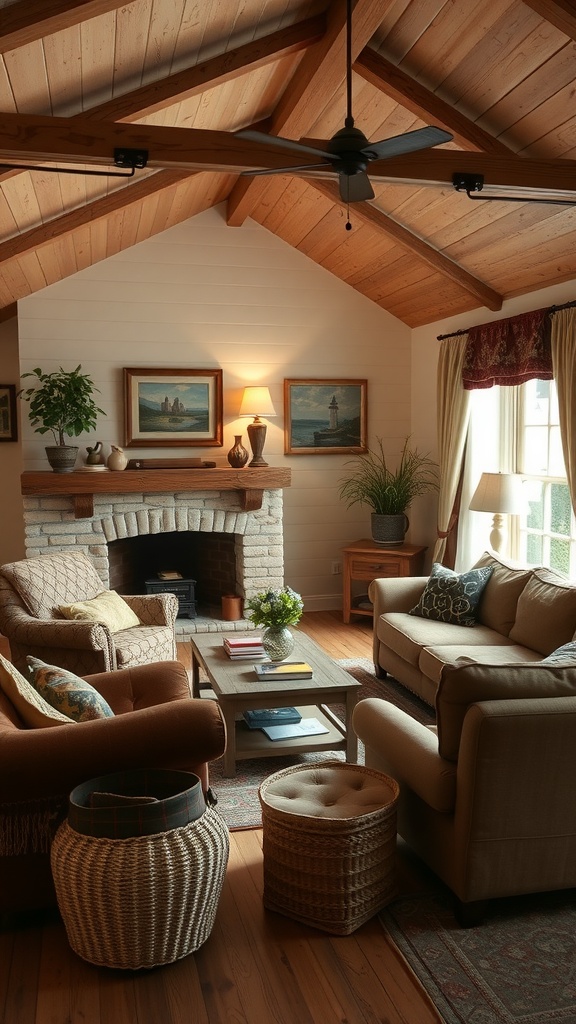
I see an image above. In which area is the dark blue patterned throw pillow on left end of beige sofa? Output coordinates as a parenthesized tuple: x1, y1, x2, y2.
(410, 562, 493, 626)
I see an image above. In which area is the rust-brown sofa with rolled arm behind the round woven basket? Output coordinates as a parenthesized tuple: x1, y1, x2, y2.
(0, 662, 225, 910)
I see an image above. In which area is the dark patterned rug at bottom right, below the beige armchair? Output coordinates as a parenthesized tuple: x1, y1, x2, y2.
(380, 889, 576, 1024)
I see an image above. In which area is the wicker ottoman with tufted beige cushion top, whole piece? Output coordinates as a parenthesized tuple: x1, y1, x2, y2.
(258, 761, 399, 935)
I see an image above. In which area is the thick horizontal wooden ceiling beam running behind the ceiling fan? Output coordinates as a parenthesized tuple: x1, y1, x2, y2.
(0, 114, 576, 195)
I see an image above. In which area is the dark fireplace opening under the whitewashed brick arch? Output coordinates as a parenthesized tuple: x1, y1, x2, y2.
(108, 530, 239, 615)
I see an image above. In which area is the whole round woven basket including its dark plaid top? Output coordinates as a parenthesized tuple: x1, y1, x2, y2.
(50, 770, 230, 970)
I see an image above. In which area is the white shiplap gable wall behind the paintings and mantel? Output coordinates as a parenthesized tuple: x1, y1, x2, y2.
(18, 208, 412, 610)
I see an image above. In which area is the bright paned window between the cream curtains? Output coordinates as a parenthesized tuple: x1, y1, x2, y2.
(512, 380, 576, 577)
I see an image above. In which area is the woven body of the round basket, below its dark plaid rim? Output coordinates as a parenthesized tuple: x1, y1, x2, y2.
(51, 807, 230, 969)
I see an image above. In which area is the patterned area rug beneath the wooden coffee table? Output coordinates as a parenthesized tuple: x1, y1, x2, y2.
(206, 658, 434, 828)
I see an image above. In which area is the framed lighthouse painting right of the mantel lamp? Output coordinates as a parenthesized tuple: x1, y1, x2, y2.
(284, 378, 368, 455)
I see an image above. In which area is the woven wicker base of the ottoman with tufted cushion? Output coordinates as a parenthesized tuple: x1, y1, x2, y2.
(258, 762, 399, 935)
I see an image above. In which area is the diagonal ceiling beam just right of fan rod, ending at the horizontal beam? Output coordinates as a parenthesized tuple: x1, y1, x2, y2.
(354, 46, 510, 154)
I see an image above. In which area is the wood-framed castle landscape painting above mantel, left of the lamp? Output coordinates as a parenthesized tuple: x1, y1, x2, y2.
(124, 368, 222, 447)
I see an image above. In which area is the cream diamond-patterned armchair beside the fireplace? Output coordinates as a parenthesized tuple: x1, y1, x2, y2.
(0, 552, 178, 675)
